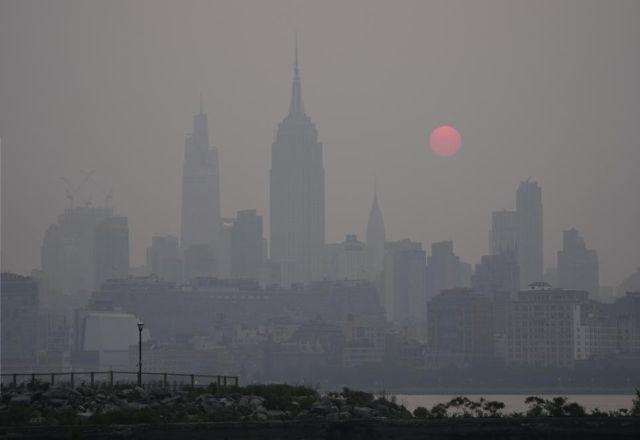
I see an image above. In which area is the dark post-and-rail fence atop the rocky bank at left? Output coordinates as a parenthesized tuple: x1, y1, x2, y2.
(0, 371, 238, 388)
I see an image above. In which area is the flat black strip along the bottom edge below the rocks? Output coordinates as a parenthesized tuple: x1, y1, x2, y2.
(0, 417, 640, 440)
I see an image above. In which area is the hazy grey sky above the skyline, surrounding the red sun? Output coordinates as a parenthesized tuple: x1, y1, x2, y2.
(0, 0, 640, 284)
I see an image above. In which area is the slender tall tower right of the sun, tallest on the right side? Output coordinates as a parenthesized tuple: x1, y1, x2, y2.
(516, 179, 543, 290)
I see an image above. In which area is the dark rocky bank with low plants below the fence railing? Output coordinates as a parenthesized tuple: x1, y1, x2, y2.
(0, 385, 412, 426)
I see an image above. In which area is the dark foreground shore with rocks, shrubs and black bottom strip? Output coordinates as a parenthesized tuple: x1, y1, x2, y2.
(0, 383, 640, 440)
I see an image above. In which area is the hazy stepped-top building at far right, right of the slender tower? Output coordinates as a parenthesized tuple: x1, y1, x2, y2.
(558, 228, 600, 295)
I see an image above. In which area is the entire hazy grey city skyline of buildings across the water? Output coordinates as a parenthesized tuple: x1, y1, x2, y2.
(8, 41, 640, 384)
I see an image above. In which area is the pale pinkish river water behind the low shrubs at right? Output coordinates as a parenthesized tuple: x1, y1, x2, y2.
(396, 394, 634, 413)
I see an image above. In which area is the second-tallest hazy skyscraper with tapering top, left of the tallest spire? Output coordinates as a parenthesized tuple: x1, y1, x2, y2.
(180, 99, 220, 276)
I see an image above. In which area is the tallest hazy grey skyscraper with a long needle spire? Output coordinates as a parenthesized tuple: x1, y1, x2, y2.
(269, 46, 325, 282)
